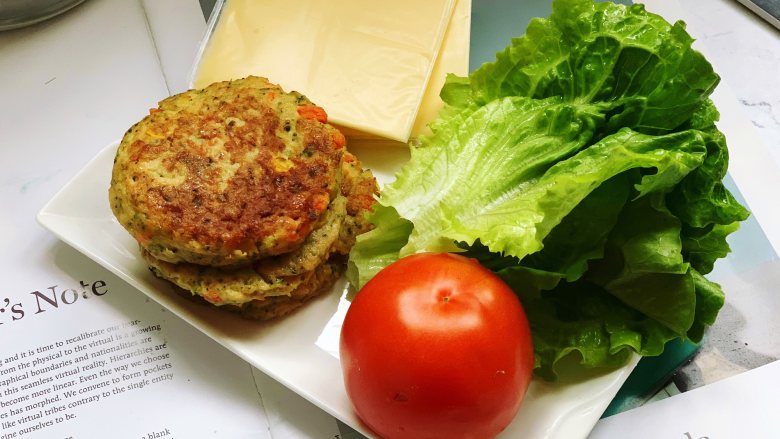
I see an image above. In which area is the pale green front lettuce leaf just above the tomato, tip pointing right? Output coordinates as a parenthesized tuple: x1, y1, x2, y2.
(386, 118, 706, 264)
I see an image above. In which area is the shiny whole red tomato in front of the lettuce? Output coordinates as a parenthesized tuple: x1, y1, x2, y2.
(340, 253, 534, 439)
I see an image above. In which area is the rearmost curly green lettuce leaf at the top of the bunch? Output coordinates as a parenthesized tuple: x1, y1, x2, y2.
(470, 0, 720, 133)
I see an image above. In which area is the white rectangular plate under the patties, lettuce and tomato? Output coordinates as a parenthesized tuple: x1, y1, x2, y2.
(38, 144, 635, 439)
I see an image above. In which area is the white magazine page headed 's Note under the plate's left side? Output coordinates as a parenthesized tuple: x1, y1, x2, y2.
(0, 0, 270, 439)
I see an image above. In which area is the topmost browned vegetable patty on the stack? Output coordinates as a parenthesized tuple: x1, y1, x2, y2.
(109, 77, 345, 266)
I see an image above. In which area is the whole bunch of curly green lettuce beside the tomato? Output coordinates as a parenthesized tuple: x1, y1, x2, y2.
(348, 0, 748, 379)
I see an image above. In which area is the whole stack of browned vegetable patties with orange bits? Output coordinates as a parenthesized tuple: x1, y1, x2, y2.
(109, 77, 378, 320)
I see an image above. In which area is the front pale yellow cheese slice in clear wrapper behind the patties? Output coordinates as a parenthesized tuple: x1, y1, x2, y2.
(192, 0, 455, 142)
